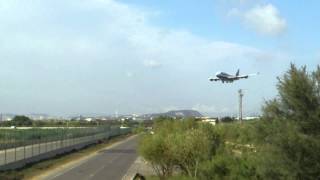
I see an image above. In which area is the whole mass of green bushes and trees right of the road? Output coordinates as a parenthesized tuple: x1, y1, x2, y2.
(139, 65, 320, 180)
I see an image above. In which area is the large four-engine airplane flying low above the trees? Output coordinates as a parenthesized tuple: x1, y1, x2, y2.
(209, 69, 259, 83)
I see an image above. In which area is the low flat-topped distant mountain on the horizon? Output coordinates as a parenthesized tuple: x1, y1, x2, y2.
(141, 110, 202, 119)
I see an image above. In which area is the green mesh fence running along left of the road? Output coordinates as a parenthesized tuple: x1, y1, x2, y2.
(0, 126, 130, 169)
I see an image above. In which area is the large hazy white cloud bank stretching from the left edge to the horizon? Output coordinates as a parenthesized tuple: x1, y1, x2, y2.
(0, 0, 288, 113)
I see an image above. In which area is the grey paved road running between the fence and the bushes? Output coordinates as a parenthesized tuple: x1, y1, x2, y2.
(49, 137, 137, 180)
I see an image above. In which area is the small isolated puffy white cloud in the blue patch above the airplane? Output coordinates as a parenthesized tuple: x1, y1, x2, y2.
(228, 4, 288, 36)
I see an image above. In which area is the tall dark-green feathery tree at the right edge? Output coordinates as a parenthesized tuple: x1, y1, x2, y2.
(257, 64, 320, 179)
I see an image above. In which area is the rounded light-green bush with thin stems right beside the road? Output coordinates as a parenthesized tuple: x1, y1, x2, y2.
(139, 117, 220, 179)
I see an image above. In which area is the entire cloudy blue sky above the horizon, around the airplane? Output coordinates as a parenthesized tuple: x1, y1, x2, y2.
(0, 0, 320, 115)
